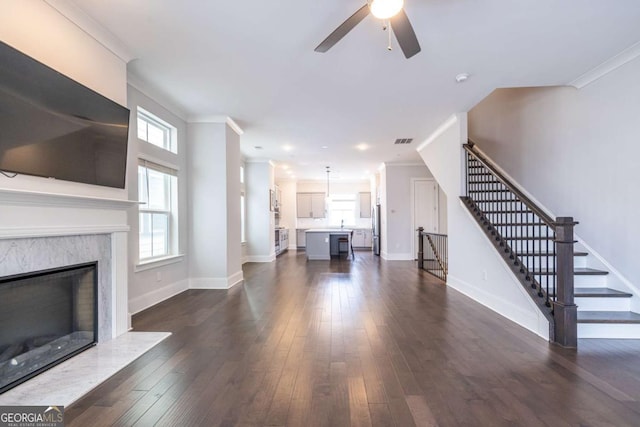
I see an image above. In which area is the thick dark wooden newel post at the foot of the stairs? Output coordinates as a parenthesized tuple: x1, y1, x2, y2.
(553, 217, 578, 347)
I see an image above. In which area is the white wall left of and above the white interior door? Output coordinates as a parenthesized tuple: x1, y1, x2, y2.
(380, 163, 433, 260)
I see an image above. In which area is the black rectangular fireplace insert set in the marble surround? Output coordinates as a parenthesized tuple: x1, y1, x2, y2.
(0, 262, 98, 393)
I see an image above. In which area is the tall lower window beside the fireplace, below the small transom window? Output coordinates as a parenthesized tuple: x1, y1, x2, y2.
(138, 160, 178, 261)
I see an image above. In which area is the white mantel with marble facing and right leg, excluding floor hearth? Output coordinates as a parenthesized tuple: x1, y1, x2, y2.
(0, 189, 137, 341)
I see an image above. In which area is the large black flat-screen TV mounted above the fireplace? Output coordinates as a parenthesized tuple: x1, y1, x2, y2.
(0, 42, 129, 188)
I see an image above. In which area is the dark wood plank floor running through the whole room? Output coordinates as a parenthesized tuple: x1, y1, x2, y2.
(65, 252, 640, 427)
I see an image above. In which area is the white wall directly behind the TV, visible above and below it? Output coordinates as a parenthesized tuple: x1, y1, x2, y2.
(0, 0, 127, 199)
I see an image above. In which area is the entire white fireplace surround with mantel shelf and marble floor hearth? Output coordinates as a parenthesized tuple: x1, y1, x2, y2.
(0, 188, 169, 405)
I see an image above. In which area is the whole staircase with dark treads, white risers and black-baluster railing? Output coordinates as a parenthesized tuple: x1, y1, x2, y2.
(461, 141, 640, 347)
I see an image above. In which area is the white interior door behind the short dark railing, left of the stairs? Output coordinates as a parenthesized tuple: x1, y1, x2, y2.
(412, 179, 438, 259)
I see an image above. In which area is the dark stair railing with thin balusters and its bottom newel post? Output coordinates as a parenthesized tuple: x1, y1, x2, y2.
(461, 141, 577, 347)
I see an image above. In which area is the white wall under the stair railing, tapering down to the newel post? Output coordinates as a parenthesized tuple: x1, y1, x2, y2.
(418, 114, 549, 339)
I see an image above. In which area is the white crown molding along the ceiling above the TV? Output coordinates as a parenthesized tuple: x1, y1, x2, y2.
(45, 0, 134, 63)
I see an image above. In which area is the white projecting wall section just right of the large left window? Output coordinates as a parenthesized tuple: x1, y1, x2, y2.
(187, 122, 242, 289)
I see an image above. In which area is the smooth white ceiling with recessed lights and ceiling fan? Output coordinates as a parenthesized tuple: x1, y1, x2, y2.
(72, 0, 640, 180)
